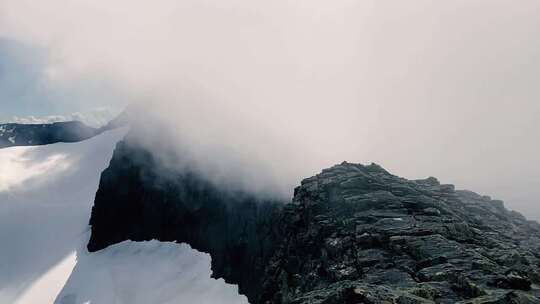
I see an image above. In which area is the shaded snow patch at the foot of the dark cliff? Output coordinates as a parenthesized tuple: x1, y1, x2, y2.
(55, 240, 248, 304)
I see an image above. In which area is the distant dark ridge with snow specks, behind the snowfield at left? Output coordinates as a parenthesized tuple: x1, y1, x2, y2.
(0, 121, 101, 148)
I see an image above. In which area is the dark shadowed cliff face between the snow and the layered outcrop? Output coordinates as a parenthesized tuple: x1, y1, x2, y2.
(88, 135, 283, 299)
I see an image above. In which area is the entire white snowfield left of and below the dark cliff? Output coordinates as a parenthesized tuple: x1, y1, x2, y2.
(0, 129, 247, 304)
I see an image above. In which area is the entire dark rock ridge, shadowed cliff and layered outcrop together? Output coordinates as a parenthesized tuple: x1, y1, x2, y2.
(88, 141, 540, 304)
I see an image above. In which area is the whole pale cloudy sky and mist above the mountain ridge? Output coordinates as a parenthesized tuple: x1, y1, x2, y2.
(0, 0, 540, 219)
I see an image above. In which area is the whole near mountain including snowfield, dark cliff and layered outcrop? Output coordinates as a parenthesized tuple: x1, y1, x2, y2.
(4, 117, 540, 304)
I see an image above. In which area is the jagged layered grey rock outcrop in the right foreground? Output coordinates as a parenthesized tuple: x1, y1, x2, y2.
(261, 163, 540, 304)
